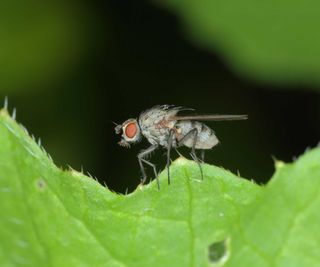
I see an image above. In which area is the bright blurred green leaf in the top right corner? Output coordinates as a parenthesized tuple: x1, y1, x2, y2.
(156, 0, 320, 88)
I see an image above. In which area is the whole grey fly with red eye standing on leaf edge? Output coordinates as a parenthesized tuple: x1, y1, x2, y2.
(115, 105, 248, 191)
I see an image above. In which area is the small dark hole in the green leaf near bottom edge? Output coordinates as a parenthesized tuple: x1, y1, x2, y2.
(208, 238, 230, 266)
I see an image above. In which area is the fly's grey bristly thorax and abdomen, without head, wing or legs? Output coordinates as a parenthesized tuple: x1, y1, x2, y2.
(139, 105, 219, 149)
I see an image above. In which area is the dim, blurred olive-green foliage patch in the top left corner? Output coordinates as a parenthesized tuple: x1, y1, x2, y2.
(0, 0, 93, 93)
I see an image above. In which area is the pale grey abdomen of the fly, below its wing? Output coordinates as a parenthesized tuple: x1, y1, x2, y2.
(175, 121, 219, 149)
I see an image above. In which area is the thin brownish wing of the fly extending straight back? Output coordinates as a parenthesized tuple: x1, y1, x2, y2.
(168, 115, 248, 121)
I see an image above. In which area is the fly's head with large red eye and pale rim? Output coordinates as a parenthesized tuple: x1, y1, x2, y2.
(114, 119, 141, 148)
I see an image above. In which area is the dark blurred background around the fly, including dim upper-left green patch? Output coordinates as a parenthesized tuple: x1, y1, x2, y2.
(0, 1, 320, 192)
